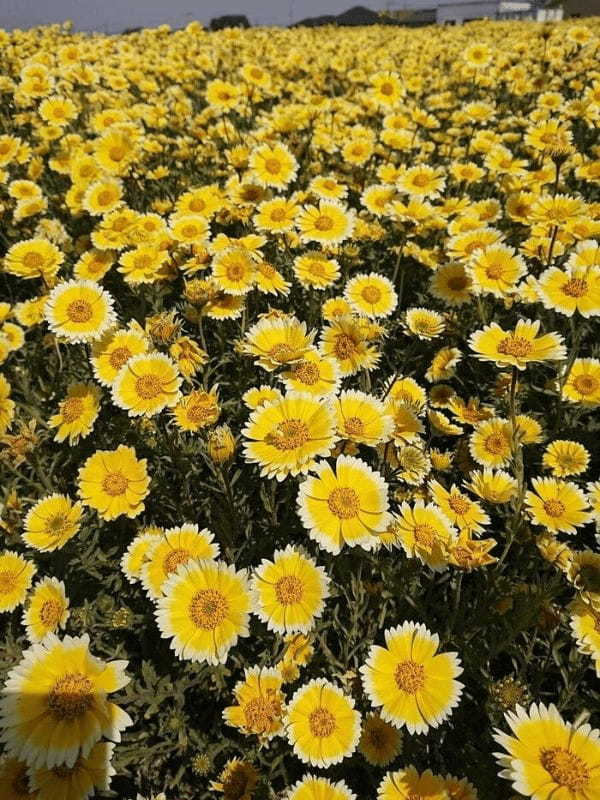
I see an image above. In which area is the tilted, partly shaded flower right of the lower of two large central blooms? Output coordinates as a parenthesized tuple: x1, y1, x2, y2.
(394, 500, 457, 571)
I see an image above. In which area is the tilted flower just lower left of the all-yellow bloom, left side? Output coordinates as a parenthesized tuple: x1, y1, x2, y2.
(23, 493, 83, 552)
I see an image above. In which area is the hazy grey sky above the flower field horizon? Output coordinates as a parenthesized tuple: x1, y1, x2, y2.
(0, 0, 438, 33)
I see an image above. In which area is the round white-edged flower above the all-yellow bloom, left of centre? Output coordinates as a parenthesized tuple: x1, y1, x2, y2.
(112, 353, 181, 417)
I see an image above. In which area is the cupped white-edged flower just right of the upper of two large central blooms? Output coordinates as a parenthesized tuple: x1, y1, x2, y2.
(334, 389, 395, 447)
